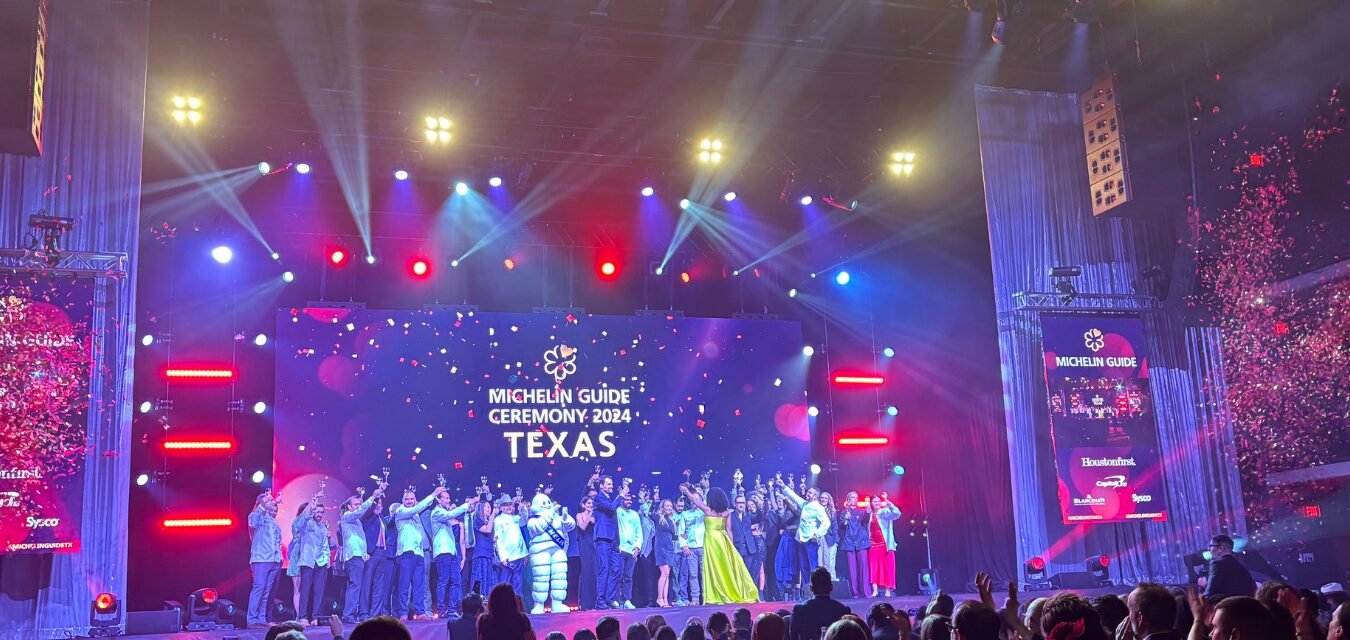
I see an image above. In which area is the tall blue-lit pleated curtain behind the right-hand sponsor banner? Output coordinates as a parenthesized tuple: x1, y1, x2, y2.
(975, 86, 1242, 582)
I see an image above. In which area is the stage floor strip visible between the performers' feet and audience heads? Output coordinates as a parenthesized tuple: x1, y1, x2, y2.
(126, 586, 1129, 640)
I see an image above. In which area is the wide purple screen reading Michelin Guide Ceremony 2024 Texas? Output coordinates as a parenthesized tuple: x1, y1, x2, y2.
(268, 309, 810, 520)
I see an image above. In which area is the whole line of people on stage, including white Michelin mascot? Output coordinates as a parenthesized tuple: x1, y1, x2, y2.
(247, 467, 900, 626)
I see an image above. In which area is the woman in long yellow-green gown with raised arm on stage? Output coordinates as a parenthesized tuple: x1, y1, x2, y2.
(680, 485, 759, 605)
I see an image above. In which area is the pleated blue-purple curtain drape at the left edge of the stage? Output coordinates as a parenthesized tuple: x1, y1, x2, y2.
(0, 0, 149, 639)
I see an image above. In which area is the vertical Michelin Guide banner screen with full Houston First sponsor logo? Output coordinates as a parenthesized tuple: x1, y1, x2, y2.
(1041, 315, 1168, 524)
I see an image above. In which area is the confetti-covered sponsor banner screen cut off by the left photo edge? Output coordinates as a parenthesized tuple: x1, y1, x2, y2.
(0, 274, 93, 554)
